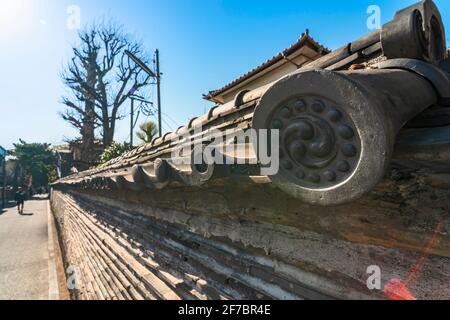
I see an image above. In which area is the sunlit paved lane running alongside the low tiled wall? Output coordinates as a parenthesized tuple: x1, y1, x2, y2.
(0, 199, 58, 300)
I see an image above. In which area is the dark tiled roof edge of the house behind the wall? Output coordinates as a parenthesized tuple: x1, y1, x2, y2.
(203, 31, 330, 100)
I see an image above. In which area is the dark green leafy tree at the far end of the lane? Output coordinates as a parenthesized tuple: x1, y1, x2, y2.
(10, 140, 57, 187)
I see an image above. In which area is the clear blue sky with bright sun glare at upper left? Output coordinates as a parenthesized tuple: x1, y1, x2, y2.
(0, 0, 450, 148)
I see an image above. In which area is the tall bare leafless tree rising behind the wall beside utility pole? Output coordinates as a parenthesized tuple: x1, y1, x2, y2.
(61, 23, 150, 152)
